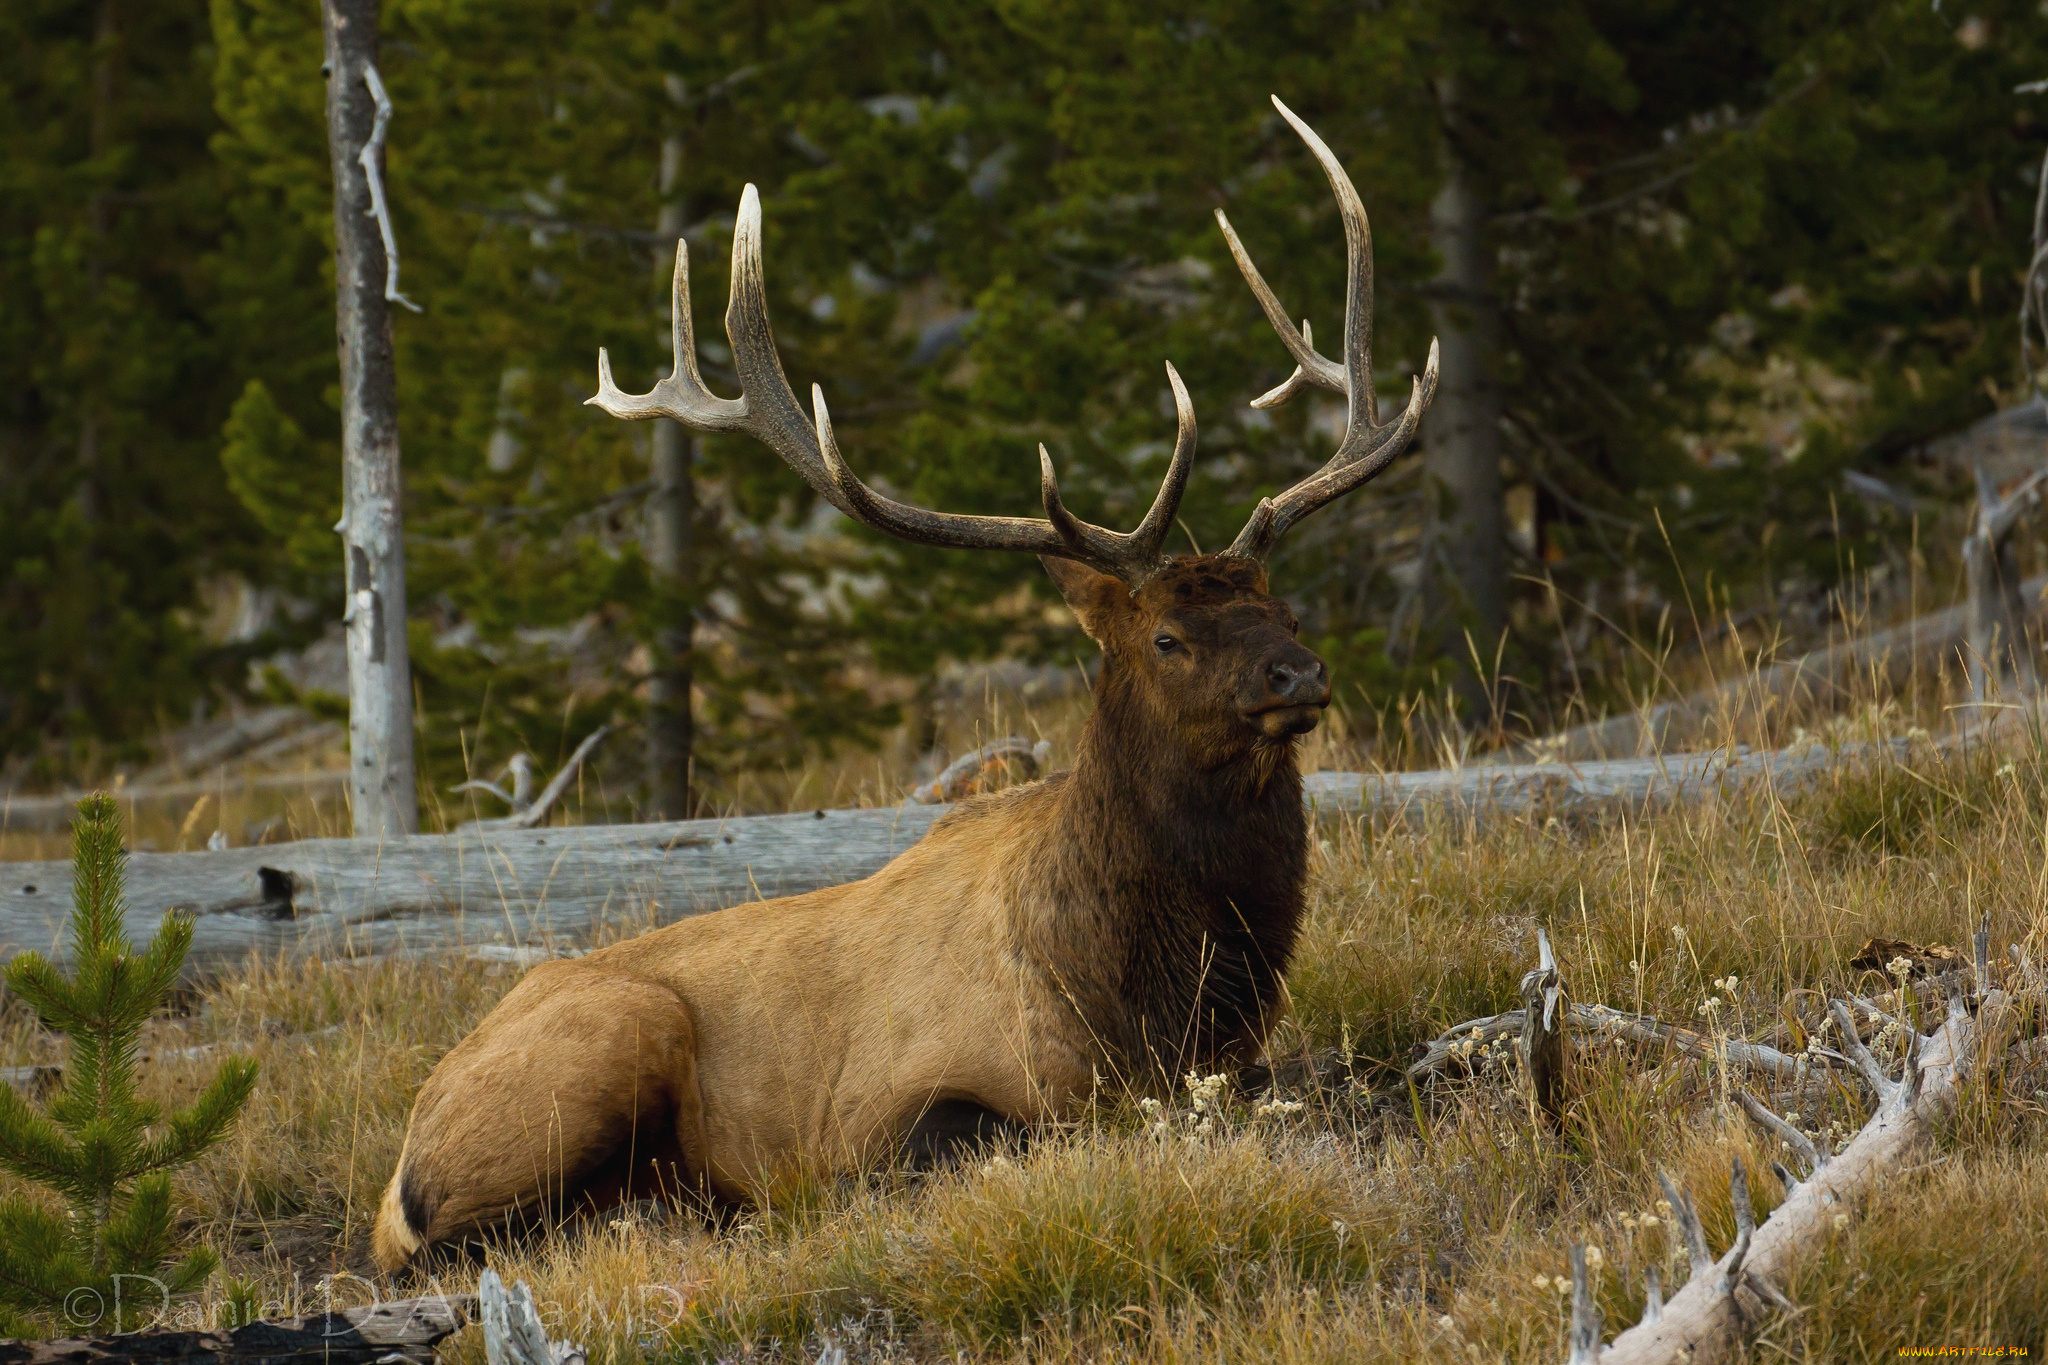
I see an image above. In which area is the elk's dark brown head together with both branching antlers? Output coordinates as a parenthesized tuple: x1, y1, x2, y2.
(590, 96, 1438, 765)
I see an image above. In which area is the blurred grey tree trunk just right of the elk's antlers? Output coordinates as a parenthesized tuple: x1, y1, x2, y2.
(1423, 78, 1507, 704)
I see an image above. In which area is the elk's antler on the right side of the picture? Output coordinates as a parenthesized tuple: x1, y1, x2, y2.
(1217, 94, 1436, 559)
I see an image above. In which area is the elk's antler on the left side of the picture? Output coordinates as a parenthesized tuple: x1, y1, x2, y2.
(586, 184, 1194, 587)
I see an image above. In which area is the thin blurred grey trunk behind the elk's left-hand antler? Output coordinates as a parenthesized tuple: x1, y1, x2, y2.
(643, 76, 696, 821)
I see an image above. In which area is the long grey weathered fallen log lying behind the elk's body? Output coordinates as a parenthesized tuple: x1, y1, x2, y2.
(0, 749, 1875, 976)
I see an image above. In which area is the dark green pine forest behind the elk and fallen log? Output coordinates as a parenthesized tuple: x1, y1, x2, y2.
(0, 0, 2048, 802)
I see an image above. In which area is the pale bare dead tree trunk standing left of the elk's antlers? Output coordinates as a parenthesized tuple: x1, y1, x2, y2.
(322, 0, 420, 837)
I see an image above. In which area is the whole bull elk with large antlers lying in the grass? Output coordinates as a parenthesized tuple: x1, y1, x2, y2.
(375, 98, 1438, 1269)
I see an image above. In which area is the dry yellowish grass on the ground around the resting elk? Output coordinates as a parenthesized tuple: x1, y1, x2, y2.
(0, 732, 2048, 1365)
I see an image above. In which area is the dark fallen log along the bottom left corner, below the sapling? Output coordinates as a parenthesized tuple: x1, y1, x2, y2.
(0, 1295, 477, 1365)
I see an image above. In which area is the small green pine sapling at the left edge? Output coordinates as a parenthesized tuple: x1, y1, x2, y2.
(0, 794, 256, 1334)
